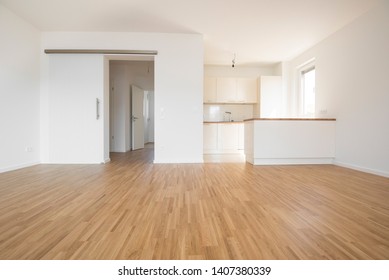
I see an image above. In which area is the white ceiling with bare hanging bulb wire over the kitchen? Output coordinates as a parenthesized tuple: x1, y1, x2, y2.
(0, 0, 380, 65)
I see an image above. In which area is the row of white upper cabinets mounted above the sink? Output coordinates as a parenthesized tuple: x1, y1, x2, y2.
(204, 77, 258, 104)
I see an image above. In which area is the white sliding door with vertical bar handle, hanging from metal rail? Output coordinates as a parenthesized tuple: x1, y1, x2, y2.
(48, 54, 104, 163)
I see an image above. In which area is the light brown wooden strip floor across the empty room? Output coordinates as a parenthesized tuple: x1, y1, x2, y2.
(0, 145, 389, 259)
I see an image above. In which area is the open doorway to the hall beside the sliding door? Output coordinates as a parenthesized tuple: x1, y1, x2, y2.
(109, 57, 155, 161)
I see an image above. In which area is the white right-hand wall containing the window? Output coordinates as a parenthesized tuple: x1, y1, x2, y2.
(288, 1, 389, 176)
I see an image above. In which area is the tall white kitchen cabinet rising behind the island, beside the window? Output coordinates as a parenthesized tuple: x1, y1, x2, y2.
(253, 76, 282, 118)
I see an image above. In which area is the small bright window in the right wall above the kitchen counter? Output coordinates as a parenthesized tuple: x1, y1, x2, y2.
(300, 64, 316, 117)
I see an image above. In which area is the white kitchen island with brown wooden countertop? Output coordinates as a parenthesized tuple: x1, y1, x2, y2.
(244, 118, 336, 165)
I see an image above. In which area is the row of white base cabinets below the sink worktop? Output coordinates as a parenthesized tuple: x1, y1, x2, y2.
(203, 123, 244, 154)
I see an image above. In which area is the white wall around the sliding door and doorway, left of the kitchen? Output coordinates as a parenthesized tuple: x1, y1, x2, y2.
(41, 32, 203, 163)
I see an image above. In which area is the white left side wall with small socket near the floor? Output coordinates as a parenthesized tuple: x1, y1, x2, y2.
(0, 4, 40, 172)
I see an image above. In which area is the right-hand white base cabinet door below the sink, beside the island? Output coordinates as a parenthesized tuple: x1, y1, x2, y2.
(218, 124, 239, 153)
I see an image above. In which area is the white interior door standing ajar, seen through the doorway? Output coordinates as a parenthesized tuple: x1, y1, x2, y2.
(131, 85, 145, 150)
